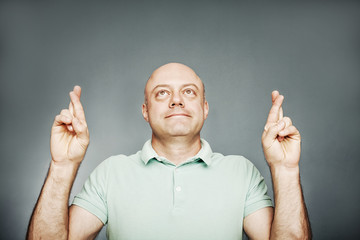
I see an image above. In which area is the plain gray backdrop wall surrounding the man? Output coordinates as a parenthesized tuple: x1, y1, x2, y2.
(0, 1, 360, 239)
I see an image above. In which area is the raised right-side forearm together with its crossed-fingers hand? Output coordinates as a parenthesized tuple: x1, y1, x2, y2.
(262, 91, 311, 239)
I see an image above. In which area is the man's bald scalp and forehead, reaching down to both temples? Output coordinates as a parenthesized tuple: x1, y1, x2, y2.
(144, 63, 205, 104)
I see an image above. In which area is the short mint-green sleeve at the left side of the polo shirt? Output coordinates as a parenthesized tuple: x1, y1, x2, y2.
(72, 160, 108, 224)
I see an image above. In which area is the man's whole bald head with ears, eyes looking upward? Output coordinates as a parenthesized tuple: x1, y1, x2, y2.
(142, 63, 209, 138)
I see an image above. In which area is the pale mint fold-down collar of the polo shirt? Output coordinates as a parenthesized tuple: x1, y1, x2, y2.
(141, 139, 213, 165)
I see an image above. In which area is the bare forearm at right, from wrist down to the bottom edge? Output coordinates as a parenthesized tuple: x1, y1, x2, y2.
(271, 167, 311, 239)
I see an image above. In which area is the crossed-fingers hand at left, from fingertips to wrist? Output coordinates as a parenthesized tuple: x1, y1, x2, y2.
(50, 86, 90, 164)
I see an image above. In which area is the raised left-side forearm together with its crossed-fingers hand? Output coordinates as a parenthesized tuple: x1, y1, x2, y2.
(27, 86, 102, 239)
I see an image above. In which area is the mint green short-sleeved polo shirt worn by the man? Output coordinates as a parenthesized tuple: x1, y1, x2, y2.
(73, 139, 272, 240)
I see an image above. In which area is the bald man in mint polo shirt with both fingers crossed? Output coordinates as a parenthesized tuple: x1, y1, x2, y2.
(28, 63, 311, 239)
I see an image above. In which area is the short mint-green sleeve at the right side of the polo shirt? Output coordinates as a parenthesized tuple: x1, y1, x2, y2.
(244, 164, 273, 217)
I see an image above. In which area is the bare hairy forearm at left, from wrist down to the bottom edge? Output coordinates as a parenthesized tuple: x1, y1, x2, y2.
(27, 162, 79, 239)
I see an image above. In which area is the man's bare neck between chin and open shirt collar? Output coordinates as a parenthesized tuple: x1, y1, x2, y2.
(151, 134, 201, 165)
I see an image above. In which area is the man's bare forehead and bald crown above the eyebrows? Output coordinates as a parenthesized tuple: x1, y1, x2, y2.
(145, 64, 203, 93)
